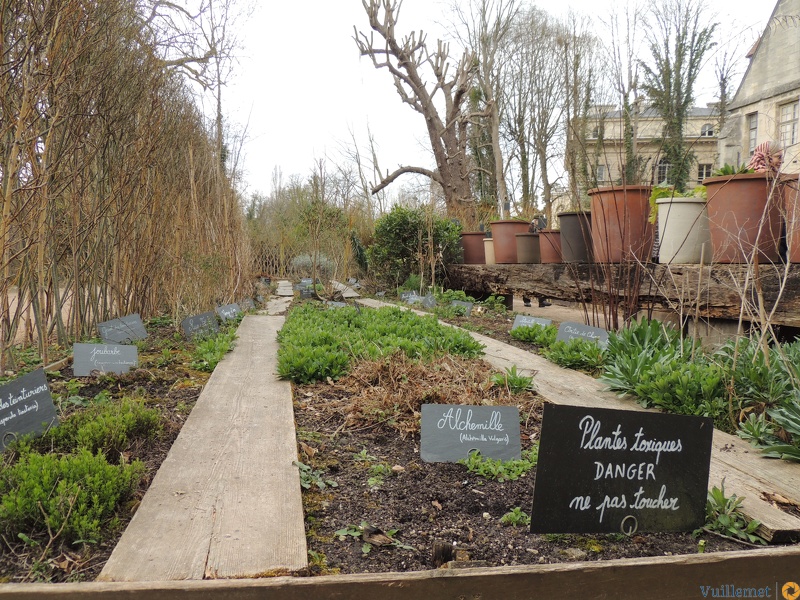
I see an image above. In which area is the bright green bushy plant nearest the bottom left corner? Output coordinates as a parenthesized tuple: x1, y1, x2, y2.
(0, 450, 144, 543)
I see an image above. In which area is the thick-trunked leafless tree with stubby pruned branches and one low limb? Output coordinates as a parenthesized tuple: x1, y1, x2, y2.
(354, 0, 475, 224)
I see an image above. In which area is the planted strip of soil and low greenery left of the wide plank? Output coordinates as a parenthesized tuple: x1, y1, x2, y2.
(0, 317, 238, 582)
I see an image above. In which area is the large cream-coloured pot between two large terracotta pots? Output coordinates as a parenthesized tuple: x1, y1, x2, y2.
(656, 197, 711, 264)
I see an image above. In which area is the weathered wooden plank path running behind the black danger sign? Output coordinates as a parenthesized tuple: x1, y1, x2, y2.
(358, 299, 800, 543)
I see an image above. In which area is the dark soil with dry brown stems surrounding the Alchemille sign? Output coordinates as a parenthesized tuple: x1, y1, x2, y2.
(295, 350, 745, 574)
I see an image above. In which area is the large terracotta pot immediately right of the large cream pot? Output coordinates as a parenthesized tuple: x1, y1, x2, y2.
(703, 173, 782, 263)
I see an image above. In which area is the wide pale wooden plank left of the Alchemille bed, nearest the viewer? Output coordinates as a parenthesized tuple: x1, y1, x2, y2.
(98, 316, 307, 581)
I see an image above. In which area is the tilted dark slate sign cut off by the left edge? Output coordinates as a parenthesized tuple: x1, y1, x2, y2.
(0, 369, 58, 450)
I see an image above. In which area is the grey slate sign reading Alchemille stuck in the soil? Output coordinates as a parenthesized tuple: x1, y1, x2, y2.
(419, 404, 521, 462)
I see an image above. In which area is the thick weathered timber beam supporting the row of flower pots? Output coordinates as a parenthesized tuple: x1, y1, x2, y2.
(448, 264, 800, 327)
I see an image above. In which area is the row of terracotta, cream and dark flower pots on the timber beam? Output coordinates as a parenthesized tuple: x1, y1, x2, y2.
(462, 173, 800, 264)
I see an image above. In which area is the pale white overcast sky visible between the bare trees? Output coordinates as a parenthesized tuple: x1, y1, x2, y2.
(223, 0, 774, 196)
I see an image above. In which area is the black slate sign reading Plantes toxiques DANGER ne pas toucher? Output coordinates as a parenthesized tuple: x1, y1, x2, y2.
(531, 403, 714, 535)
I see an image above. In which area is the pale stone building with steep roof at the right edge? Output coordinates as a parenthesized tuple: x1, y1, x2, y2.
(719, 0, 800, 173)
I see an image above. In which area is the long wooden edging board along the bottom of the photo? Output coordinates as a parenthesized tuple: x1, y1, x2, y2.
(0, 547, 800, 600)
